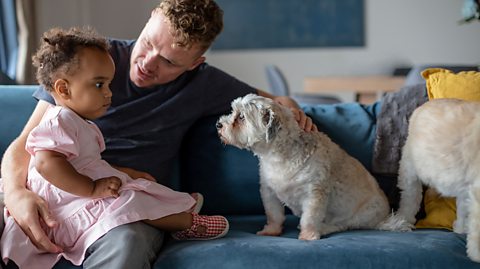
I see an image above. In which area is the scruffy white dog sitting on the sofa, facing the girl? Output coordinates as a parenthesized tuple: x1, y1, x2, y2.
(217, 94, 404, 240)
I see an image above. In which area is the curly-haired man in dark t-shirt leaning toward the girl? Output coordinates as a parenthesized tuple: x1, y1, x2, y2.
(1, 0, 316, 268)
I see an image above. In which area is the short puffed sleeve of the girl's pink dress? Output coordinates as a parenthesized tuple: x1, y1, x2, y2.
(26, 110, 79, 159)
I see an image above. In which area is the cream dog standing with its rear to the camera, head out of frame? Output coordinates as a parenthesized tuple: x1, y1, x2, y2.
(397, 99, 480, 262)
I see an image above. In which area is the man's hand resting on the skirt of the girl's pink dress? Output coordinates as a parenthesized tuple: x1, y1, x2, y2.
(5, 186, 63, 253)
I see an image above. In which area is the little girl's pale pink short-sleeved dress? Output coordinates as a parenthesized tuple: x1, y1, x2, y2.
(0, 106, 195, 269)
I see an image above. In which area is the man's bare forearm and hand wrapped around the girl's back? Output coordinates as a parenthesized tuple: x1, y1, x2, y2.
(1, 101, 62, 253)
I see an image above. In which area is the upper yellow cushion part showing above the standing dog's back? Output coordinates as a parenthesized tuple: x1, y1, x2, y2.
(422, 68, 480, 101)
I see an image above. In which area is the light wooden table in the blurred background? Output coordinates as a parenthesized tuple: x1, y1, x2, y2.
(304, 76, 405, 104)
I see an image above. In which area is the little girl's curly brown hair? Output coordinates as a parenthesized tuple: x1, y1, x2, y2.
(32, 27, 110, 91)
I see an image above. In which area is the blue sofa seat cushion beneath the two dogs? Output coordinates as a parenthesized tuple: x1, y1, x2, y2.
(154, 216, 480, 269)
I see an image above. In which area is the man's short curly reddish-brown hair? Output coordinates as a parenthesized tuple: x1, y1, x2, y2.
(155, 0, 223, 50)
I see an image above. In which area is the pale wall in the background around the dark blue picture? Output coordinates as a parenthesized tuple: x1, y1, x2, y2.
(37, 0, 480, 99)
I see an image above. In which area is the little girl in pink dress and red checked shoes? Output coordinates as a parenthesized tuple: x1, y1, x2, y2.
(0, 28, 229, 268)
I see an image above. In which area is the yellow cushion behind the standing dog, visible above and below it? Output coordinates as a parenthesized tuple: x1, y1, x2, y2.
(416, 68, 480, 230)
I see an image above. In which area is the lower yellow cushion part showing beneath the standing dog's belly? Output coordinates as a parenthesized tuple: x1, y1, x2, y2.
(415, 189, 457, 230)
